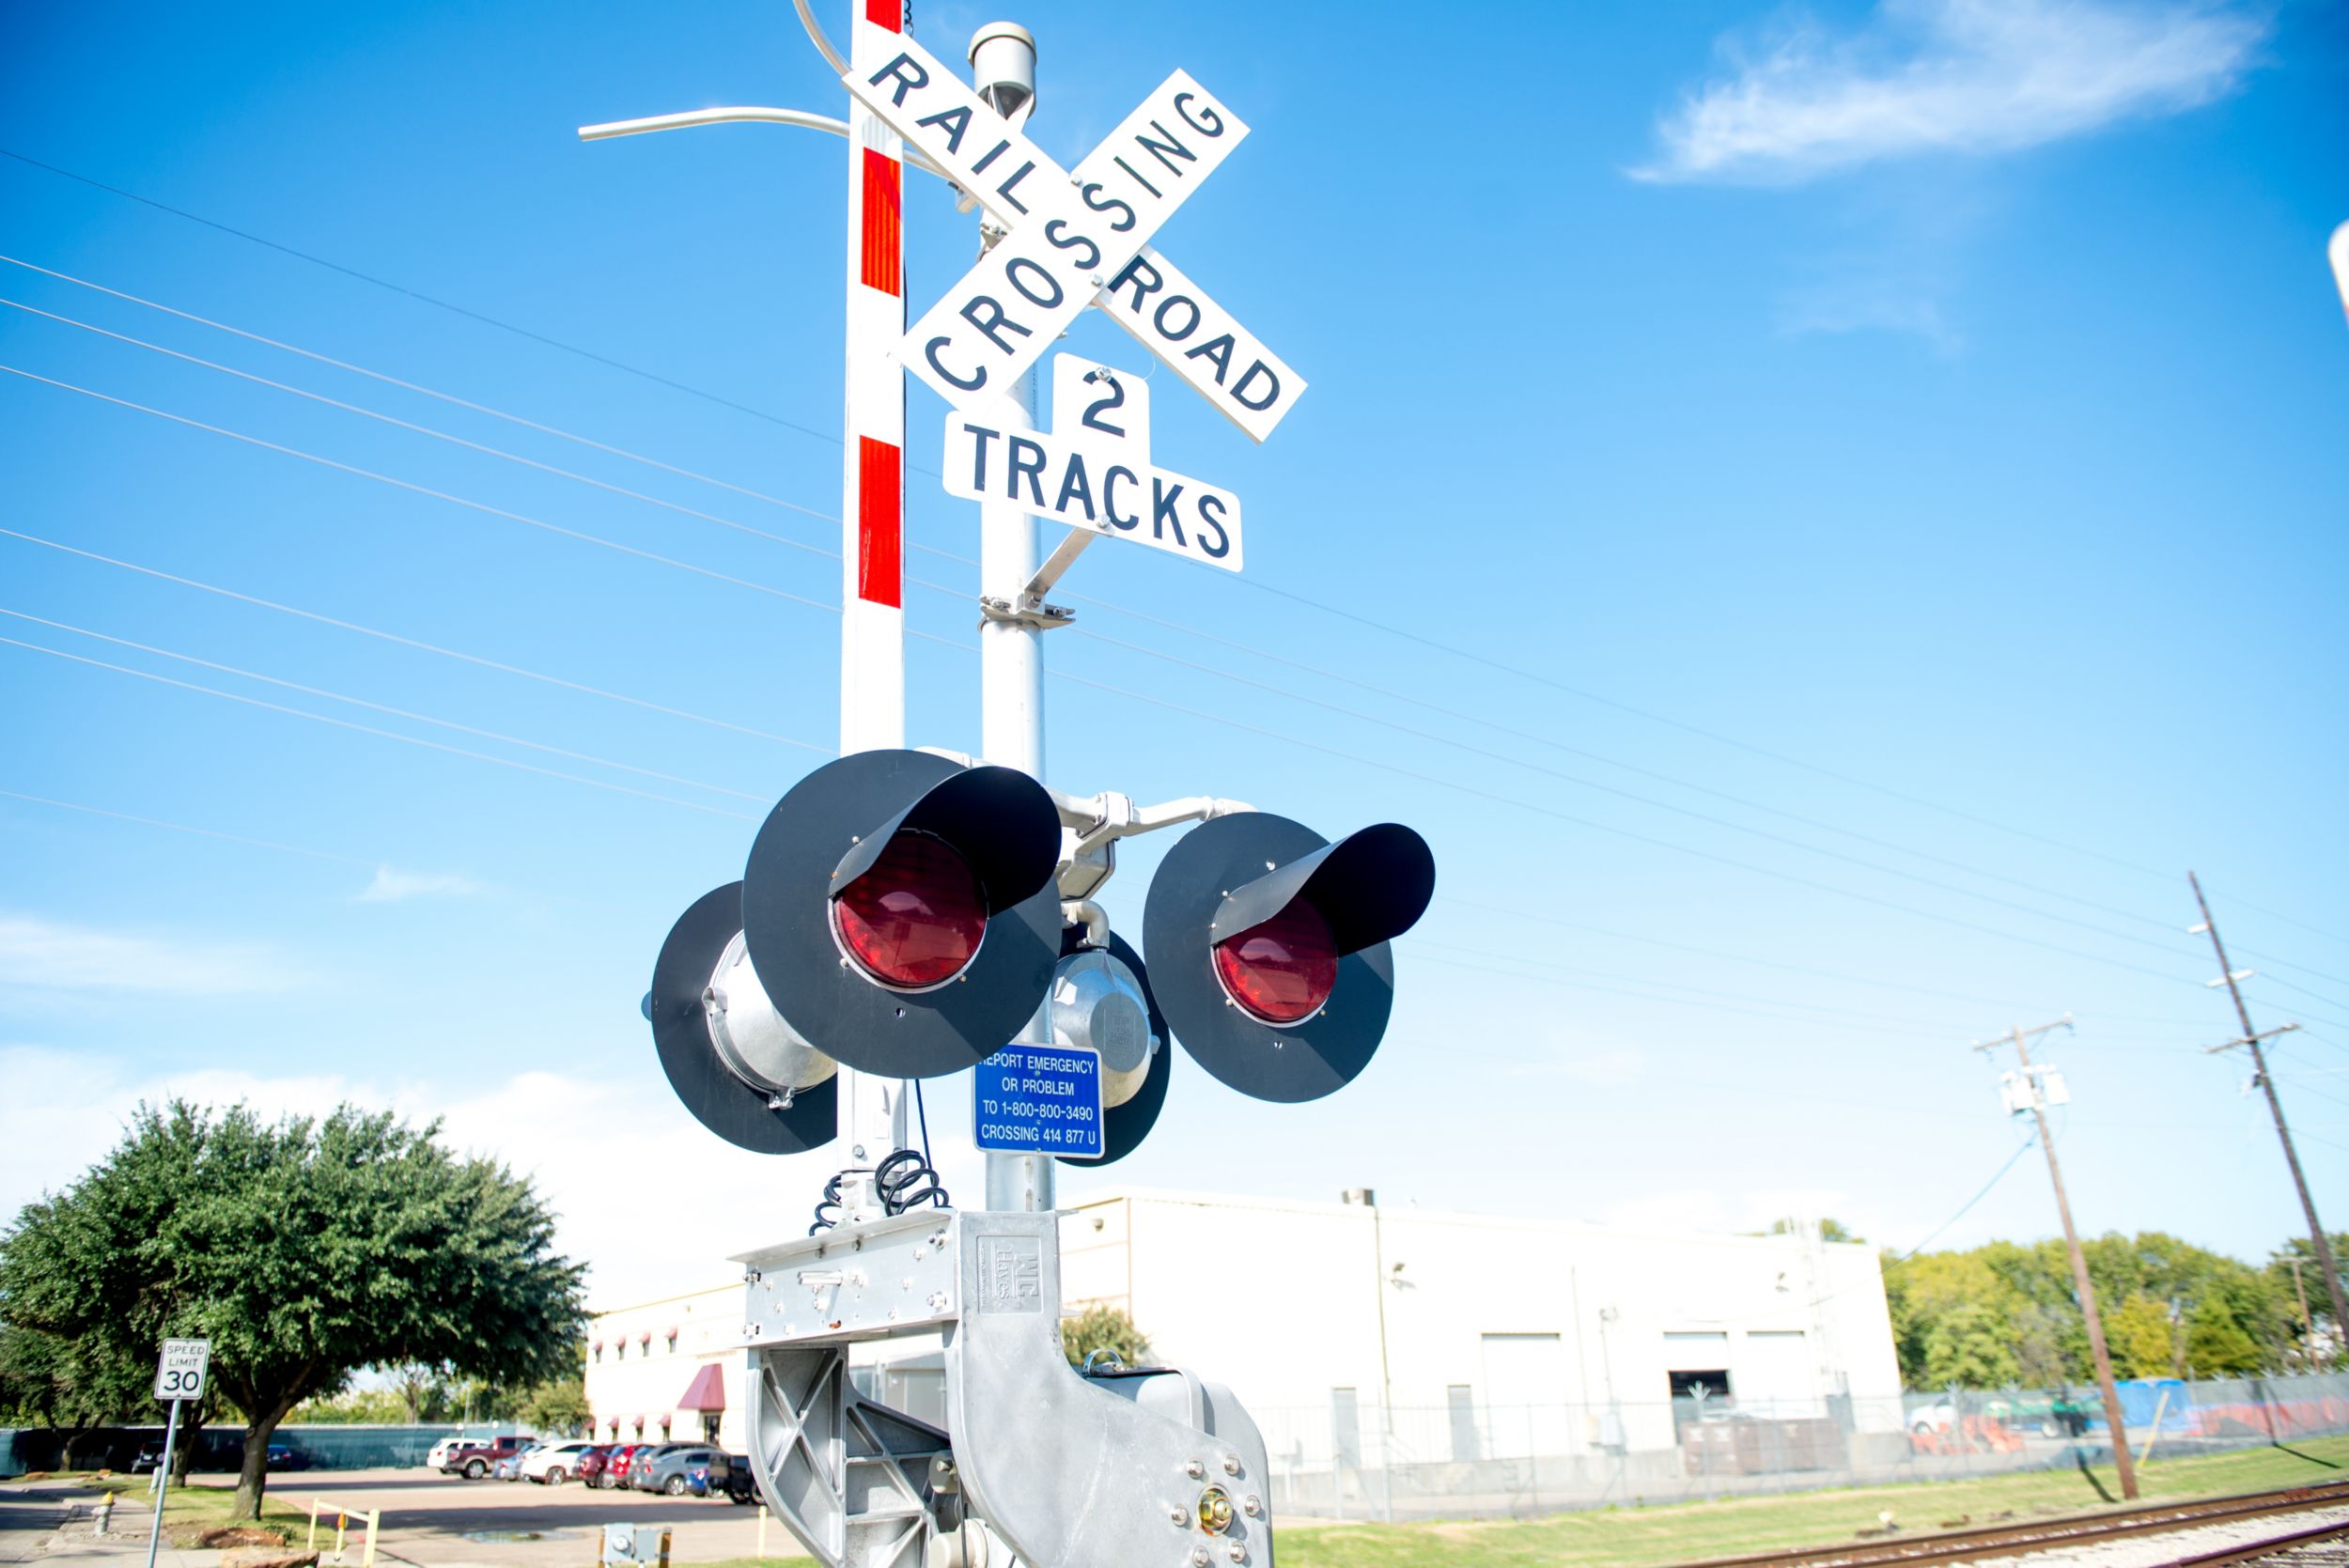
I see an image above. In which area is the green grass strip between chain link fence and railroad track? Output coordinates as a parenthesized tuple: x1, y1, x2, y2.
(1278, 1436, 2349, 1568)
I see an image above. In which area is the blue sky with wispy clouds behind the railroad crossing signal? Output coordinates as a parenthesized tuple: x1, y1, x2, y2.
(0, 0, 2349, 1298)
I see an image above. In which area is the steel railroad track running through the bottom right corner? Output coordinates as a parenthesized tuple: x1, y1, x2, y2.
(1682, 1482, 2349, 1568)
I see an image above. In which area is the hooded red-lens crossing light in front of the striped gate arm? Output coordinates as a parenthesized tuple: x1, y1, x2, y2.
(742, 752, 1062, 1078)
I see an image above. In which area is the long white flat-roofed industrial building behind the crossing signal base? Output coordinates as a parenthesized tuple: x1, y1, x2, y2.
(587, 1190, 1906, 1512)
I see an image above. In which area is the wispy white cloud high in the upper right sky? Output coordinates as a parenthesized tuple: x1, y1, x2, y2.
(1633, 0, 2267, 180)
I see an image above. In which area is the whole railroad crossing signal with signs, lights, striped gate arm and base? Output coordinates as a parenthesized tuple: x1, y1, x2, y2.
(581, 0, 1436, 1568)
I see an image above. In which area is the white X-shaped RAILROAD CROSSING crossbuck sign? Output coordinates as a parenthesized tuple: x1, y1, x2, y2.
(841, 38, 1306, 442)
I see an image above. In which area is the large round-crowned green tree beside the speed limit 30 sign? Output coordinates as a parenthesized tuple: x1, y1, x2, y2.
(0, 1101, 585, 1519)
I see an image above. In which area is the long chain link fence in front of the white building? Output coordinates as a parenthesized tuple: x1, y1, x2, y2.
(1250, 1375, 2349, 1519)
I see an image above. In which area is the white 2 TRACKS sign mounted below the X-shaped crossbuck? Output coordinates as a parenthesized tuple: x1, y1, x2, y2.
(942, 354, 1240, 573)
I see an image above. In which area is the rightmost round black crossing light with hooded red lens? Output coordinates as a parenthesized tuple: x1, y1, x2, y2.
(1142, 812, 1436, 1101)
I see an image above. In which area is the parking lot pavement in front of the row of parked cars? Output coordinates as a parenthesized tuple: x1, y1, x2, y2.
(271, 1469, 801, 1568)
